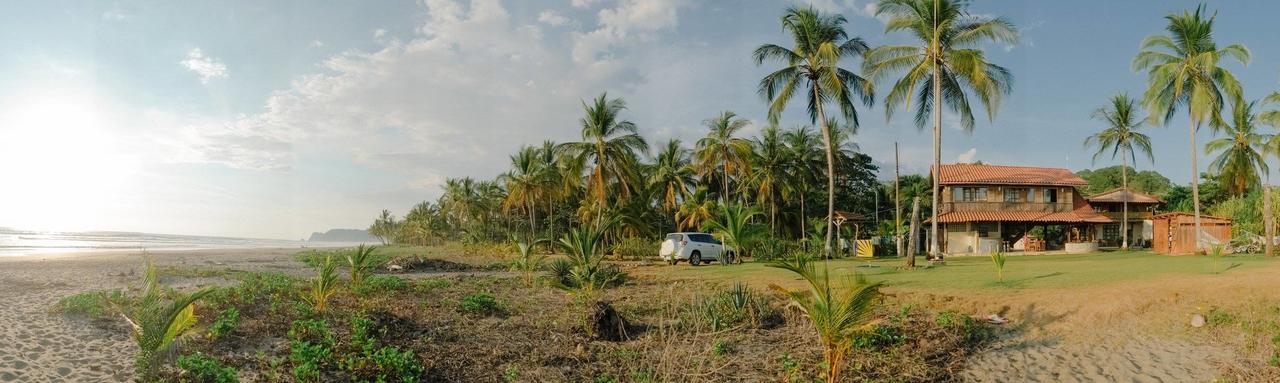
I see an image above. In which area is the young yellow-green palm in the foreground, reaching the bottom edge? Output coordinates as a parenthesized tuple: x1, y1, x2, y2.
(769, 255, 879, 383)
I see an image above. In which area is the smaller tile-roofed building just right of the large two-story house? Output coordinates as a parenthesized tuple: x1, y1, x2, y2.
(1085, 187, 1164, 247)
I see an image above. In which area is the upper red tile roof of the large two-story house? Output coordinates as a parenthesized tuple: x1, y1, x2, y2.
(942, 164, 1089, 186)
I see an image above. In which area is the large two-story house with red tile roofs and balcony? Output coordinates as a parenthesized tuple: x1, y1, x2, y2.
(937, 164, 1114, 254)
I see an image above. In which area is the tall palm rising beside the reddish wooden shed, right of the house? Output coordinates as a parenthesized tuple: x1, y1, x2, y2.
(1133, 5, 1249, 249)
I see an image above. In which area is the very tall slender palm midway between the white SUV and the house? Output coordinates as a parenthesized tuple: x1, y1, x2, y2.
(753, 8, 874, 257)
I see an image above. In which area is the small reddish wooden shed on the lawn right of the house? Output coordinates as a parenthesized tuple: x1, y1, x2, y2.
(1151, 211, 1231, 255)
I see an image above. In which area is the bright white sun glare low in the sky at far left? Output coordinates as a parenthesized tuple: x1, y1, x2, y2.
(0, 86, 136, 231)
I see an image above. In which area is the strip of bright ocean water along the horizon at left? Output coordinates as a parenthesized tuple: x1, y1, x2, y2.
(0, 228, 360, 256)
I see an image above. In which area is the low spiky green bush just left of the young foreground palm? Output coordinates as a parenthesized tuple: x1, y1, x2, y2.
(681, 283, 782, 332)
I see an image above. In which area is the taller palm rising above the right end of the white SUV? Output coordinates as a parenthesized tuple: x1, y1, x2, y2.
(694, 110, 751, 204)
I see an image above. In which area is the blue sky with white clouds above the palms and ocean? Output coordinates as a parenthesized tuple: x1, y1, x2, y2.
(0, 0, 1280, 238)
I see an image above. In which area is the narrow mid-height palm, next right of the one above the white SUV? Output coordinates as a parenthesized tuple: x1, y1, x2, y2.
(748, 126, 788, 234)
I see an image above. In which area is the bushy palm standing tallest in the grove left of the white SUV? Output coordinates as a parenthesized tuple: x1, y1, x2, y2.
(561, 92, 649, 220)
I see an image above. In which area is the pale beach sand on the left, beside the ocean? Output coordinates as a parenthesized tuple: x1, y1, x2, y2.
(0, 249, 306, 382)
